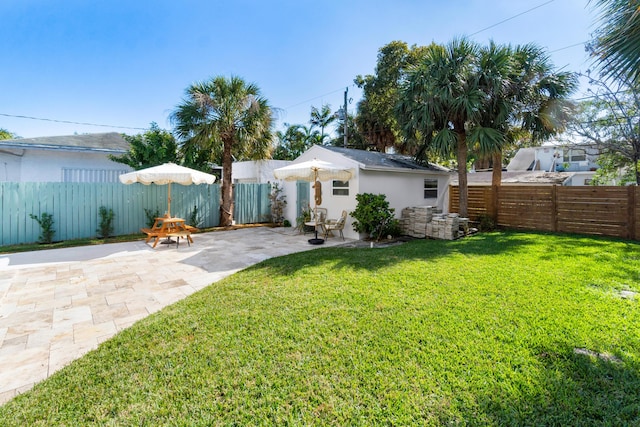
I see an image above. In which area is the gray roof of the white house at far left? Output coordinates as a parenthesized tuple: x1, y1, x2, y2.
(0, 132, 129, 154)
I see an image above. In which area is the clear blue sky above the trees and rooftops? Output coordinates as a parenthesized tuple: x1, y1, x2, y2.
(0, 0, 596, 138)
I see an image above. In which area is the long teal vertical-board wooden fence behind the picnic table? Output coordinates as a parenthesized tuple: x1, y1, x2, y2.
(0, 182, 270, 245)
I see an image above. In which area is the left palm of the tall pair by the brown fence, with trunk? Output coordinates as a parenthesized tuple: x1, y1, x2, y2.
(396, 38, 490, 217)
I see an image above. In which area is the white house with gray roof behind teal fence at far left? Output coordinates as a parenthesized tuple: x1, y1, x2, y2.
(0, 132, 132, 182)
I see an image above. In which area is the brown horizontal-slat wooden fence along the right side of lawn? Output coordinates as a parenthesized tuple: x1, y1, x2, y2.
(449, 185, 640, 240)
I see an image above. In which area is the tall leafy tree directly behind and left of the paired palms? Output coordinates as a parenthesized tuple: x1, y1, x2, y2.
(354, 41, 427, 152)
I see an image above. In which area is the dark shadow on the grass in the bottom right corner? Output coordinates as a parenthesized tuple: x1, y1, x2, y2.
(476, 349, 640, 426)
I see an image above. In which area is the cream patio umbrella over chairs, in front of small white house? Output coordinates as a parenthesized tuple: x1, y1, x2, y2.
(273, 159, 353, 244)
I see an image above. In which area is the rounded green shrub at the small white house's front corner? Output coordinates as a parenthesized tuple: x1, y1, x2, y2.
(350, 193, 399, 240)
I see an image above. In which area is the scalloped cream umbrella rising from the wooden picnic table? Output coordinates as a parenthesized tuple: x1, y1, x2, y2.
(118, 163, 216, 216)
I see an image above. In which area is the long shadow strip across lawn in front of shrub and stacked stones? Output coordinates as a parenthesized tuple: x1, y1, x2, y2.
(254, 232, 535, 275)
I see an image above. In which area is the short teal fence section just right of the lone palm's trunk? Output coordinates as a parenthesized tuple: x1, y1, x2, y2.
(233, 184, 271, 224)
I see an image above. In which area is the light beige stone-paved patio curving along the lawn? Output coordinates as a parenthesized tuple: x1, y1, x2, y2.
(0, 227, 345, 404)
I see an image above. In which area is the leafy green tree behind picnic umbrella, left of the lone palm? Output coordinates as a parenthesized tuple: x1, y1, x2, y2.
(109, 123, 178, 170)
